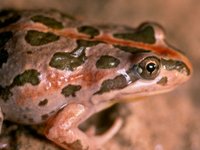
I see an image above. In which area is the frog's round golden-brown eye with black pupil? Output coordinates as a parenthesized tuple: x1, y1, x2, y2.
(137, 56, 160, 80)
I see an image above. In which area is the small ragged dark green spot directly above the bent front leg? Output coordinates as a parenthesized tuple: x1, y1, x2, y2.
(61, 84, 81, 97)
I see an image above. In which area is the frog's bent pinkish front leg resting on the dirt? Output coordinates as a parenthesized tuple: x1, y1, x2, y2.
(45, 104, 122, 150)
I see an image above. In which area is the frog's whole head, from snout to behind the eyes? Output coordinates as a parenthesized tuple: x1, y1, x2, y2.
(94, 24, 192, 102)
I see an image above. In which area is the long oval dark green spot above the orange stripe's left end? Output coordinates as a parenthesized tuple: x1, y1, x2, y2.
(31, 15, 63, 29)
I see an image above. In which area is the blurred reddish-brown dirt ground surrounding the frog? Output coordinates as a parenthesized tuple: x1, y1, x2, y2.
(0, 0, 200, 150)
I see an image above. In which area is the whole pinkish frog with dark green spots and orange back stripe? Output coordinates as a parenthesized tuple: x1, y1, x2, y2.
(0, 9, 192, 150)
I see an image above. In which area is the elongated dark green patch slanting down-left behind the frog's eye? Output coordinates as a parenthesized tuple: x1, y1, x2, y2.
(95, 75, 128, 94)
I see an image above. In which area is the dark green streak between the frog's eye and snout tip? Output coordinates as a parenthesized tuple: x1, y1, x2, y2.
(161, 59, 190, 75)
